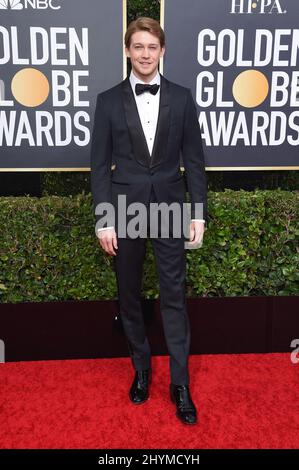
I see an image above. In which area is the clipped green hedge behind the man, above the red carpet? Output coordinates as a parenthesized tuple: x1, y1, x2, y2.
(0, 190, 298, 302)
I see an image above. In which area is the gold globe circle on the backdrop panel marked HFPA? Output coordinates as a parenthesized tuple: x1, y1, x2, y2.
(233, 70, 269, 108)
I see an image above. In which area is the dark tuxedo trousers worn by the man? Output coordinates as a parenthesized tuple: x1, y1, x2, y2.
(114, 185, 190, 385)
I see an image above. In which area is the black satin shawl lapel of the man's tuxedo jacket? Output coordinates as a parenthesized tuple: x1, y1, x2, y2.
(122, 74, 170, 167)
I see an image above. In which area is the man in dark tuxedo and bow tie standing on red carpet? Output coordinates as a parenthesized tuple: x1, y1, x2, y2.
(91, 17, 207, 424)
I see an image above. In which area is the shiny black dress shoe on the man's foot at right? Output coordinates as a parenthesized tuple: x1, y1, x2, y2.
(170, 384, 197, 424)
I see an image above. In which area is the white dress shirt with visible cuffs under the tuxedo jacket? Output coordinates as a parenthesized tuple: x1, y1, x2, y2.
(98, 70, 205, 232)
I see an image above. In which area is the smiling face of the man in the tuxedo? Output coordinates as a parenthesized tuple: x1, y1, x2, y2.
(125, 31, 165, 82)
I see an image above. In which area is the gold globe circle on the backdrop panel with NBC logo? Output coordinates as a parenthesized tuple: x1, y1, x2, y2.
(11, 68, 50, 108)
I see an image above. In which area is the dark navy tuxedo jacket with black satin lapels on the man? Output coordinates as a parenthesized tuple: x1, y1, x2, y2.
(91, 74, 208, 232)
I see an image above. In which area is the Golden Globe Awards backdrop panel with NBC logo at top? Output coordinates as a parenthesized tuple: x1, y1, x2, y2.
(0, 0, 125, 171)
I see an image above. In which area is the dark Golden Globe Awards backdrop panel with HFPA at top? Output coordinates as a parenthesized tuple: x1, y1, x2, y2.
(161, 0, 299, 170)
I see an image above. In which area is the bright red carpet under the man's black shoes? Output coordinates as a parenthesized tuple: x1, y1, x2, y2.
(0, 354, 299, 449)
